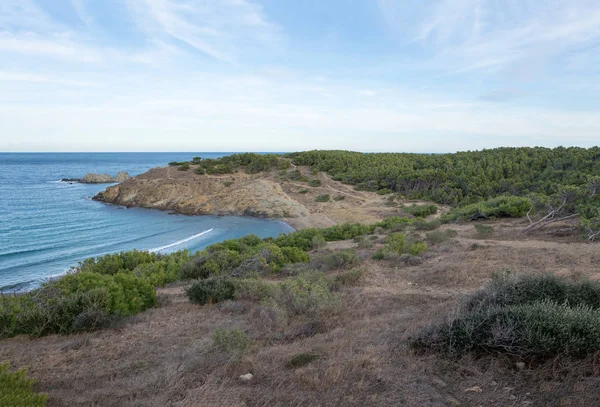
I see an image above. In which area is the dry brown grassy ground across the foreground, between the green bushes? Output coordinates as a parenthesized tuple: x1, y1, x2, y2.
(0, 220, 600, 406)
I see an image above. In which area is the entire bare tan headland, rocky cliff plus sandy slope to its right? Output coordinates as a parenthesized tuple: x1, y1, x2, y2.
(94, 167, 397, 229)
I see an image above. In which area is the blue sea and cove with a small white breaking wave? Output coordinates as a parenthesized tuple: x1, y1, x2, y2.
(0, 153, 293, 291)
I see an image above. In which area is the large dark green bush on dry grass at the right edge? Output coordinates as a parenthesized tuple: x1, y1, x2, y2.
(413, 275, 600, 360)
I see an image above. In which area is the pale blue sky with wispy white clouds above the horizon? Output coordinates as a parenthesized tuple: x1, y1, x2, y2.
(0, 0, 600, 152)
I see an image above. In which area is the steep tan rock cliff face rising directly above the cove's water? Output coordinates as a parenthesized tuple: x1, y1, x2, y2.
(94, 167, 308, 218)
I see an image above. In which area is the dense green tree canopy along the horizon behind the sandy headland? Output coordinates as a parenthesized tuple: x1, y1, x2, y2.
(288, 147, 600, 206)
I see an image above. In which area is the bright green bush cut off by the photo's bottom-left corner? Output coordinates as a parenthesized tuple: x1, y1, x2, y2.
(0, 363, 48, 407)
